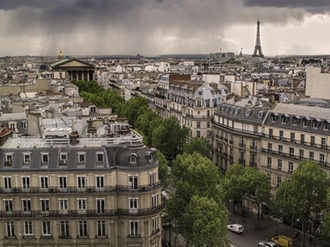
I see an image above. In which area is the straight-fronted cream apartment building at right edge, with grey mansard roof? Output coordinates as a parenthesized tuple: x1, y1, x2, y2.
(260, 103, 330, 188)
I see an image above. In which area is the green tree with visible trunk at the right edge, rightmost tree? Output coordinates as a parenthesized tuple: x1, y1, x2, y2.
(275, 161, 329, 246)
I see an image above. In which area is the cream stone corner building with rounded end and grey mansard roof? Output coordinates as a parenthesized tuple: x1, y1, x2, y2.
(0, 130, 165, 247)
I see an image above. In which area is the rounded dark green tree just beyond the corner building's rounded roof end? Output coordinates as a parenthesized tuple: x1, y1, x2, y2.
(152, 116, 190, 158)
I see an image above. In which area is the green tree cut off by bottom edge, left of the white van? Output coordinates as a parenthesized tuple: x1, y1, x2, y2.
(183, 196, 228, 247)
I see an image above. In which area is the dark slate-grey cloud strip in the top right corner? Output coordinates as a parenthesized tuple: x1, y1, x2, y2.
(244, 0, 330, 13)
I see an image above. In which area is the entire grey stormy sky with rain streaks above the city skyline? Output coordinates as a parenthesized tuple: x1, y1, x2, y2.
(0, 0, 330, 56)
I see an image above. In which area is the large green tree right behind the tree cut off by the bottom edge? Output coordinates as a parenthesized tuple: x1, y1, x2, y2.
(166, 152, 227, 245)
